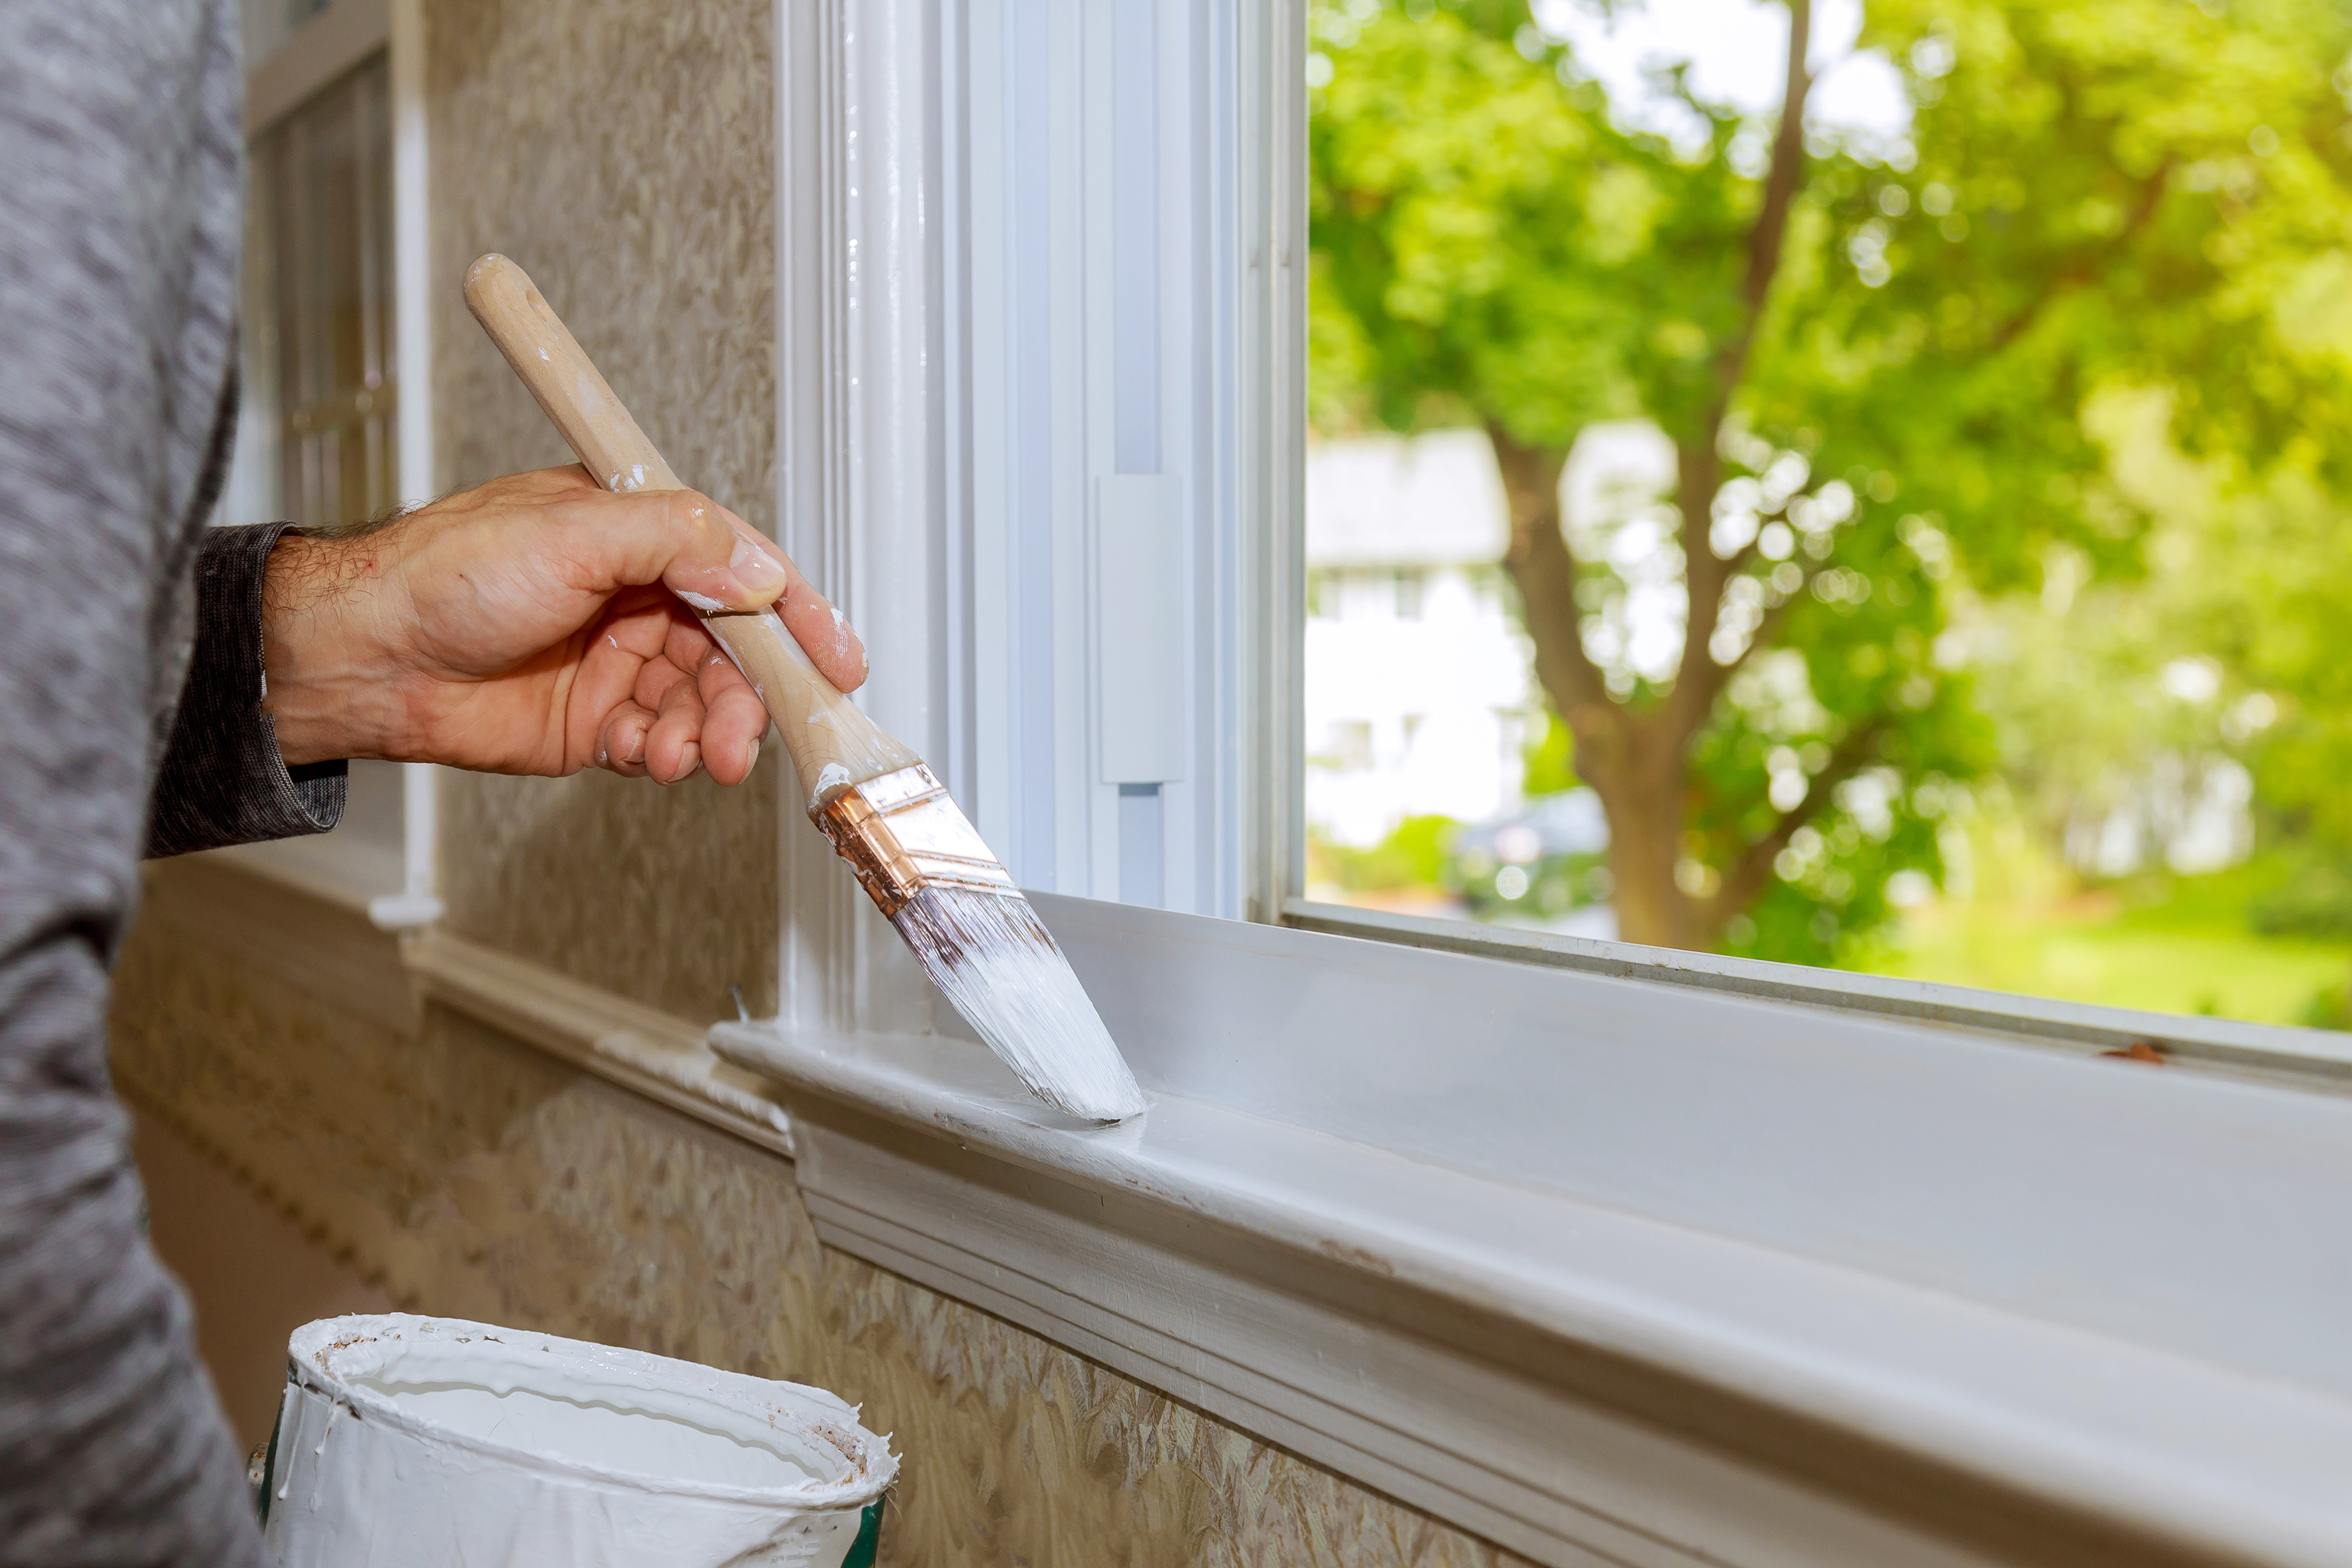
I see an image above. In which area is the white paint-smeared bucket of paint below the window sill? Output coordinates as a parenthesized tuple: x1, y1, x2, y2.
(259, 1314, 898, 1568)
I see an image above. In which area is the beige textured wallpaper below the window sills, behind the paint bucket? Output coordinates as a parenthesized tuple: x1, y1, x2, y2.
(115, 874, 1522, 1568)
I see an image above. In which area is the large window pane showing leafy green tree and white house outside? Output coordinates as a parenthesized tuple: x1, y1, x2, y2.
(1303, 0, 2352, 1025)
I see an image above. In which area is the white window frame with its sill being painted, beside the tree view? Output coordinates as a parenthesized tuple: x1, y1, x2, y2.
(729, 0, 2352, 1568)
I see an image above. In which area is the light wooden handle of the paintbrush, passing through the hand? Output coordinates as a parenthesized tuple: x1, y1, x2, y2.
(466, 254, 920, 811)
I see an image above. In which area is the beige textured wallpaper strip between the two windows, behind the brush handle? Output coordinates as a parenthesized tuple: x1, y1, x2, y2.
(426, 0, 783, 1020)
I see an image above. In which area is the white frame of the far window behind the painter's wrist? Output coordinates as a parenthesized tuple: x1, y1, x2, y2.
(219, 0, 442, 931)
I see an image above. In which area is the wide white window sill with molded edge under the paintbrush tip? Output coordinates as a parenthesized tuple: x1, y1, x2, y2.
(713, 898, 2352, 1568)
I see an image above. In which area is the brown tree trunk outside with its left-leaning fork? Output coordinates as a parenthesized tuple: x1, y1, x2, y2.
(1486, 423, 1705, 947)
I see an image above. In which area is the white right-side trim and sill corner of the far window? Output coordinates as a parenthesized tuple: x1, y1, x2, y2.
(223, 0, 442, 931)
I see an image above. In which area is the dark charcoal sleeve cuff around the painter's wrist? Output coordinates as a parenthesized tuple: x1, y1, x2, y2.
(148, 522, 346, 860)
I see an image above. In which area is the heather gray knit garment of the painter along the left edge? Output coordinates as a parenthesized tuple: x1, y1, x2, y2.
(0, 0, 266, 1568)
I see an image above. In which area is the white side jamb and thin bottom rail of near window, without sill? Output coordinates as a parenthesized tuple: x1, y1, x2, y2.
(776, 0, 2345, 1084)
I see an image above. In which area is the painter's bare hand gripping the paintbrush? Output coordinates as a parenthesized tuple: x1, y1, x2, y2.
(263, 468, 866, 785)
